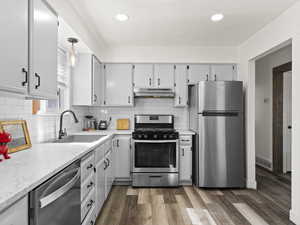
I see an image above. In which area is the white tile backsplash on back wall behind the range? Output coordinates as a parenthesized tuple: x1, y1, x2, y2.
(89, 98, 189, 130)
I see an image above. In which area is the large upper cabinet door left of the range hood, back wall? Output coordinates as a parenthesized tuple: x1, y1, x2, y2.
(105, 64, 133, 106)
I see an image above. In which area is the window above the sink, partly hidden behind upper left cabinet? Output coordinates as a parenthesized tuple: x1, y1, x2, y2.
(32, 48, 70, 115)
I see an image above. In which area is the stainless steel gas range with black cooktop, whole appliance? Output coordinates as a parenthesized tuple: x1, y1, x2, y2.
(131, 115, 179, 187)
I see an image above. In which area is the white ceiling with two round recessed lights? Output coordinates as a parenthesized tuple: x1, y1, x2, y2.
(69, 0, 298, 46)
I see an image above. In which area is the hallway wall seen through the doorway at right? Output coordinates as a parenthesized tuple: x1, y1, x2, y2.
(255, 45, 292, 169)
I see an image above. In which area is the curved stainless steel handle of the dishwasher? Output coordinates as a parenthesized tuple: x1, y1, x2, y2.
(40, 168, 80, 209)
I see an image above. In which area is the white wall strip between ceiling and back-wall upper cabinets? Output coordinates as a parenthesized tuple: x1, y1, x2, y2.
(105, 46, 238, 63)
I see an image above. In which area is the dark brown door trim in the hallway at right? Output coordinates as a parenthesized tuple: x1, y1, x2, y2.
(272, 62, 292, 174)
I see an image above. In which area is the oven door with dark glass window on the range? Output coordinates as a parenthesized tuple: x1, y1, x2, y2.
(132, 140, 179, 173)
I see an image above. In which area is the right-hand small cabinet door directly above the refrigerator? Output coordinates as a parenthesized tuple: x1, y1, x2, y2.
(211, 64, 236, 81)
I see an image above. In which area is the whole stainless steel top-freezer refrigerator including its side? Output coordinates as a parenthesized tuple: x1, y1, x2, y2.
(189, 81, 245, 188)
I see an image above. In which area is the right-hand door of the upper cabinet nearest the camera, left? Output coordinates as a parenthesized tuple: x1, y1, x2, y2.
(30, 0, 58, 98)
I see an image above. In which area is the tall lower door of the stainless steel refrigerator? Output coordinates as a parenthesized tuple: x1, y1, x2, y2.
(197, 112, 245, 188)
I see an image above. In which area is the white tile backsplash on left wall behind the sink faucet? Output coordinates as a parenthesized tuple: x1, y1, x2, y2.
(0, 96, 87, 143)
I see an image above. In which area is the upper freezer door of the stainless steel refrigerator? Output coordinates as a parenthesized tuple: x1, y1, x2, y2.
(198, 81, 243, 113)
